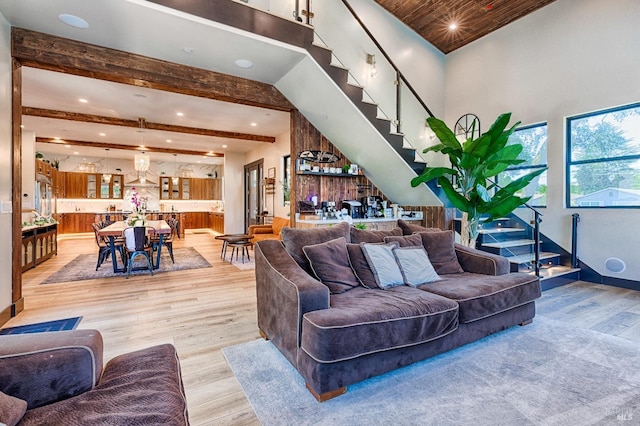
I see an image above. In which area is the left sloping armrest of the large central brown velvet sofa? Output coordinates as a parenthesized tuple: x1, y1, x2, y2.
(254, 240, 329, 366)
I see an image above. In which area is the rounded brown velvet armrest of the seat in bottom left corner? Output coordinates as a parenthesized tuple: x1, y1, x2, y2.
(0, 330, 103, 409)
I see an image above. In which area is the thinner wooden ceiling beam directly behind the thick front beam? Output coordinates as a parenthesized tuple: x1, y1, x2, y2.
(22, 107, 276, 143)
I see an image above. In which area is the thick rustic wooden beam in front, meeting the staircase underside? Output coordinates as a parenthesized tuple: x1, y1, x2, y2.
(11, 27, 295, 111)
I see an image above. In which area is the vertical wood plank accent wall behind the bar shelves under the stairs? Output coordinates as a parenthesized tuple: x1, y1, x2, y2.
(291, 111, 444, 229)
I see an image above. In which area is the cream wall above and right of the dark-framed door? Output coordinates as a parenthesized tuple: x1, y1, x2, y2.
(245, 132, 295, 218)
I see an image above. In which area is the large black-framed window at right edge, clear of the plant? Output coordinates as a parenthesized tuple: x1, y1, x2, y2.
(566, 104, 640, 208)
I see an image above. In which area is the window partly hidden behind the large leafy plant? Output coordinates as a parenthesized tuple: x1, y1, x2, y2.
(499, 123, 547, 207)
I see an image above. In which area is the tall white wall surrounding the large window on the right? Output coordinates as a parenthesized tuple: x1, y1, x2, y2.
(445, 0, 640, 280)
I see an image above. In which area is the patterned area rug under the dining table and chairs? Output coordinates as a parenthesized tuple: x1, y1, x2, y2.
(40, 247, 211, 284)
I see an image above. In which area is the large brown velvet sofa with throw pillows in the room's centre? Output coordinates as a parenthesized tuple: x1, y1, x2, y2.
(255, 223, 541, 401)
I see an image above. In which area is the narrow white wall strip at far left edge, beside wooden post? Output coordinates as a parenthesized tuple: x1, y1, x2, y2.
(0, 14, 12, 312)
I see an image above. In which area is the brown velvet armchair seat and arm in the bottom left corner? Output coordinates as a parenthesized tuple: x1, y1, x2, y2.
(0, 330, 189, 426)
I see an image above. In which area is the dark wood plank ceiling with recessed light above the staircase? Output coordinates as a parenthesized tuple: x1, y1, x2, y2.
(376, 0, 555, 53)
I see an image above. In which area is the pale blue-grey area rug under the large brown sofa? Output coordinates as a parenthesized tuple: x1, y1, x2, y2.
(223, 316, 640, 425)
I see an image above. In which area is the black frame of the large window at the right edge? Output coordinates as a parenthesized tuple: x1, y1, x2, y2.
(565, 102, 640, 209)
